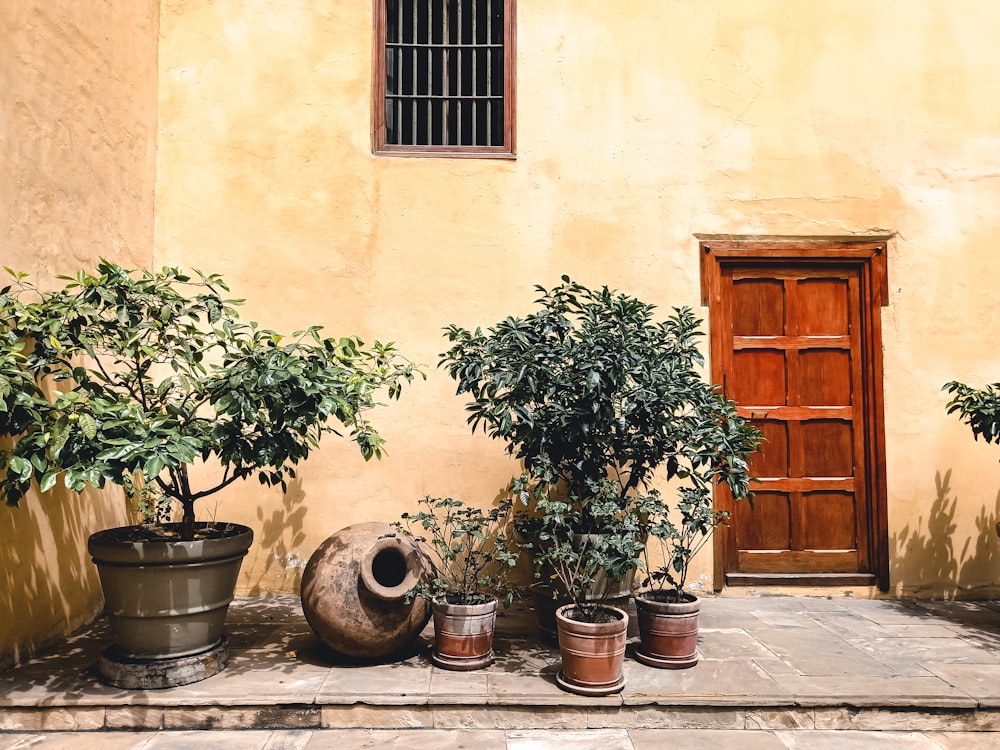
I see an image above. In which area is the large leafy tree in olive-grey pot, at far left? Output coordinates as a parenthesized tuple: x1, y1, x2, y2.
(0, 261, 419, 687)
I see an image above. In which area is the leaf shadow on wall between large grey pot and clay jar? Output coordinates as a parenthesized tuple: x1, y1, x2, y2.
(247, 477, 311, 596)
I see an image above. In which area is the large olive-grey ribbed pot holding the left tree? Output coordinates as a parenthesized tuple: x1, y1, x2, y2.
(87, 524, 253, 664)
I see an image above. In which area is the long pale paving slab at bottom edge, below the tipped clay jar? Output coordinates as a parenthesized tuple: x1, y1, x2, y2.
(304, 729, 505, 750)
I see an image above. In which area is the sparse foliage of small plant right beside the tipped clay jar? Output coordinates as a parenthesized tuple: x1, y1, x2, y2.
(395, 496, 517, 606)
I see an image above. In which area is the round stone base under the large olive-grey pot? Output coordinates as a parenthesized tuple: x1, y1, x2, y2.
(97, 636, 229, 690)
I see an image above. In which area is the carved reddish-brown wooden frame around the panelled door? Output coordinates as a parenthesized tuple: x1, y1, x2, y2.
(694, 234, 894, 591)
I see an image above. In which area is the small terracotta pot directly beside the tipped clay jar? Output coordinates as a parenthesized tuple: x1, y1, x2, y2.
(431, 599, 497, 672)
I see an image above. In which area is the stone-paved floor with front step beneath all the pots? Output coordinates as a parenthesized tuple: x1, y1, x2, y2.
(0, 596, 1000, 750)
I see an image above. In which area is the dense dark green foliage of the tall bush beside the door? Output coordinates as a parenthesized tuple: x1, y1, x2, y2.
(441, 276, 756, 507)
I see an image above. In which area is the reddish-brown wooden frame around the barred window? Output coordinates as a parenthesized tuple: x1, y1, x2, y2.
(372, 0, 517, 159)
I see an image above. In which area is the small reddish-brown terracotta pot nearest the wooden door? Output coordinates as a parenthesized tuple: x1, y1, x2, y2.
(635, 591, 701, 669)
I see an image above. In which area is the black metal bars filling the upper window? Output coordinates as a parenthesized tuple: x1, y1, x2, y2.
(385, 0, 505, 146)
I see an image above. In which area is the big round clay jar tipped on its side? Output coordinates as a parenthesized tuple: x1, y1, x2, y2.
(301, 522, 434, 660)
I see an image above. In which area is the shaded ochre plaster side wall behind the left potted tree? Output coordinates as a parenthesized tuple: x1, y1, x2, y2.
(0, 0, 158, 664)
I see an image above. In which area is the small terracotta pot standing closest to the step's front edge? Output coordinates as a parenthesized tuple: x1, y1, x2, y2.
(556, 604, 628, 695)
